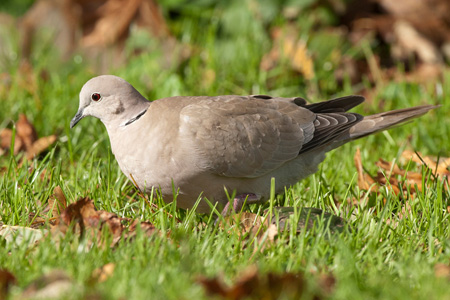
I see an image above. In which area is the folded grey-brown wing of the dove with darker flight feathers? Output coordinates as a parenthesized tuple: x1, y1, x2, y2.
(180, 95, 361, 178)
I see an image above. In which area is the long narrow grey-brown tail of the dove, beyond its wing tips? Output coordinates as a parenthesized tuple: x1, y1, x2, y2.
(345, 105, 440, 140)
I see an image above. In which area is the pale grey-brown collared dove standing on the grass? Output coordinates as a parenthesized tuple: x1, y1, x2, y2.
(70, 75, 436, 212)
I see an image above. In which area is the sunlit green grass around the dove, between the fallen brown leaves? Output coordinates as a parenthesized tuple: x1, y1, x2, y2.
(0, 1, 450, 299)
